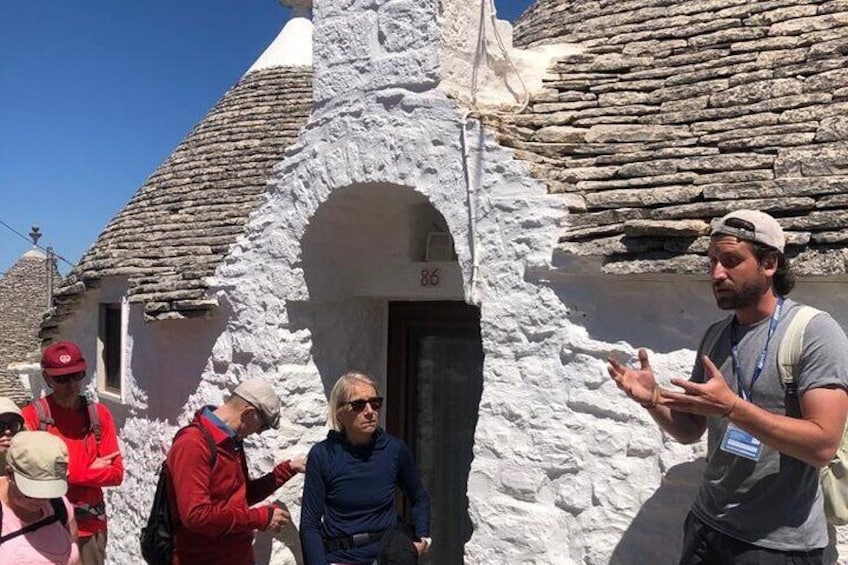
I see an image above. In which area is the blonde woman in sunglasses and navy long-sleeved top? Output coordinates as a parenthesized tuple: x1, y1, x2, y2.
(300, 372, 430, 565)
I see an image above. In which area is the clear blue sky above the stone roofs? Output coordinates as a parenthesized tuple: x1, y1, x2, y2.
(0, 0, 531, 273)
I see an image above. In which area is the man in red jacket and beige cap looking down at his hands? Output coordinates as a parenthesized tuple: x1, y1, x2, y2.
(167, 379, 306, 565)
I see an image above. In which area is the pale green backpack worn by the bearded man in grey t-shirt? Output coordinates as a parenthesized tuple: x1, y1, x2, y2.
(777, 306, 848, 526)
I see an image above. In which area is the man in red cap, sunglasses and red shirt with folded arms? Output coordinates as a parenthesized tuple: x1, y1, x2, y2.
(22, 341, 124, 565)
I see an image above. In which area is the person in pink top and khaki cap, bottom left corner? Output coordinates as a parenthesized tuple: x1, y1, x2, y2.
(0, 431, 80, 565)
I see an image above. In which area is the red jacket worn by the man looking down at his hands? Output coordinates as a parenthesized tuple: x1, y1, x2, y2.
(167, 412, 295, 565)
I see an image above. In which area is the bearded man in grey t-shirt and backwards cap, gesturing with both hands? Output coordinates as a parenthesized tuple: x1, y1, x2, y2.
(609, 210, 848, 565)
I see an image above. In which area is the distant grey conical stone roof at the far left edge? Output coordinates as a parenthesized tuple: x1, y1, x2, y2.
(0, 250, 59, 404)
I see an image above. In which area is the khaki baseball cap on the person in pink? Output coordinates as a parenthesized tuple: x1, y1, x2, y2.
(6, 431, 68, 498)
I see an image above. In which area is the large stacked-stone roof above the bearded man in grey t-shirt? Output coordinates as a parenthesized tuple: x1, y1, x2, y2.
(504, 0, 848, 275)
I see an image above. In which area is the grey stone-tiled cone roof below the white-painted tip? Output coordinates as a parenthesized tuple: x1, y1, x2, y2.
(43, 67, 312, 330)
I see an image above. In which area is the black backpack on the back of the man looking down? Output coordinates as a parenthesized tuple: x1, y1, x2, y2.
(140, 423, 218, 565)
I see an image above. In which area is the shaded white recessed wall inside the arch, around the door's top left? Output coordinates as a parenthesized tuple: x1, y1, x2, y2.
(287, 183, 463, 393)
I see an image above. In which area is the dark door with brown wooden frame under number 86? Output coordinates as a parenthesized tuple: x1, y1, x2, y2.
(386, 302, 483, 565)
